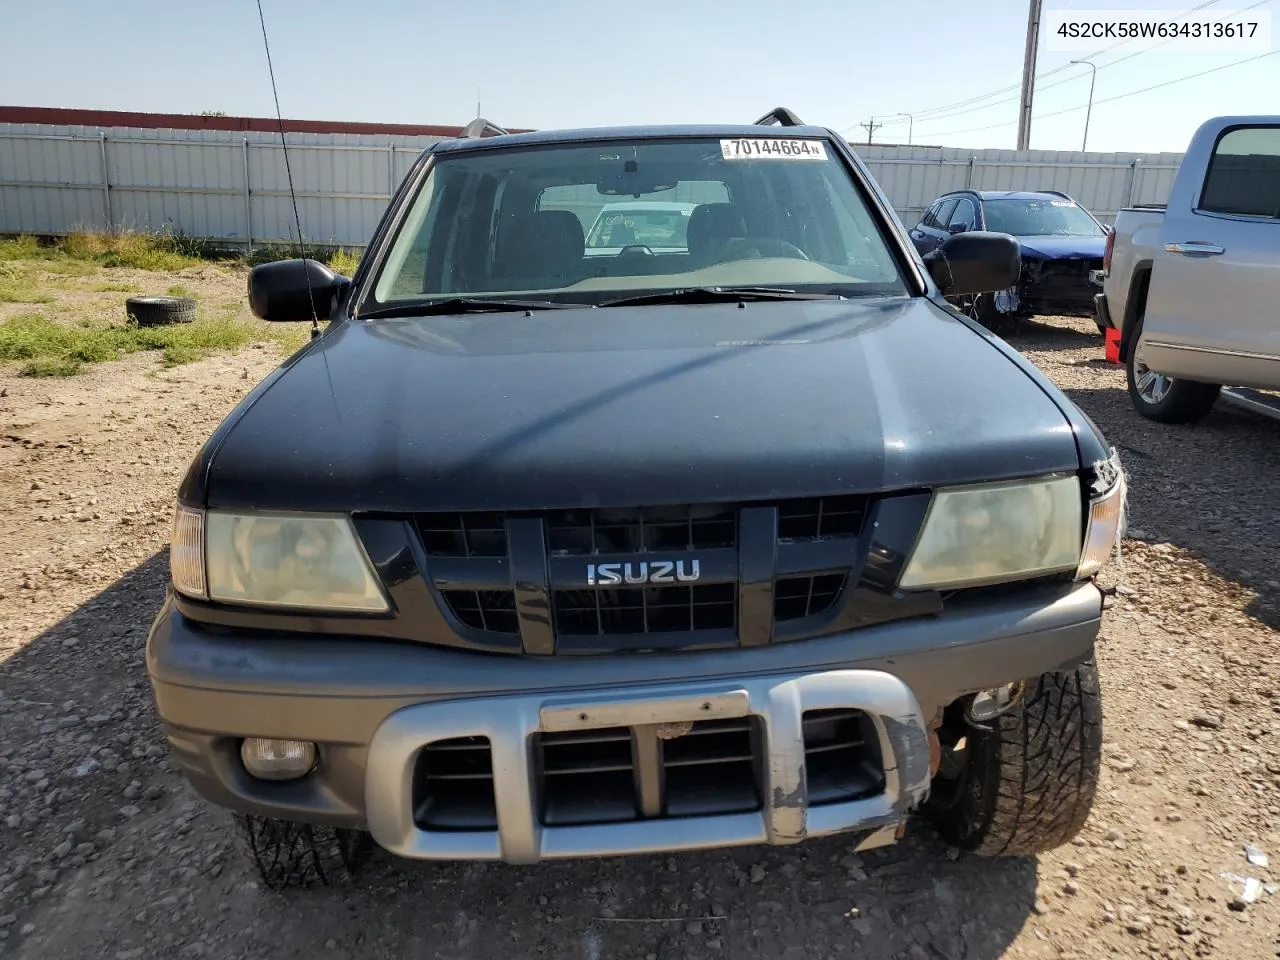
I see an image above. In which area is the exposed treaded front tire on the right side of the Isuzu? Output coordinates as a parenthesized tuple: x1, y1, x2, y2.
(924, 659, 1102, 856)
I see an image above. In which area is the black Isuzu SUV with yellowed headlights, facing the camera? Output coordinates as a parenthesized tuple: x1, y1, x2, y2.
(147, 109, 1124, 886)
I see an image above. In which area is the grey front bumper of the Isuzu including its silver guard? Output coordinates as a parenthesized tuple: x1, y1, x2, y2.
(140, 584, 1102, 863)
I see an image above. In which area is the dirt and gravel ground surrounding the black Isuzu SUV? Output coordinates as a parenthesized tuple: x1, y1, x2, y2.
(0, 284, 1280, 960)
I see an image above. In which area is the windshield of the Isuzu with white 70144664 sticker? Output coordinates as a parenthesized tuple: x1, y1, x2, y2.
(370, 137, 906, 305)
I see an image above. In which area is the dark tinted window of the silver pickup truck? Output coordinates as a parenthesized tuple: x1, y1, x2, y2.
(1199, 127, 1280, 218)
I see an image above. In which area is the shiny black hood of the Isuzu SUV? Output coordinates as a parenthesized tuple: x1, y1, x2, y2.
(201, 298, 1079, 512)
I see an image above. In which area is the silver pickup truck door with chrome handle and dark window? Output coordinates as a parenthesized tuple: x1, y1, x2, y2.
(1143, 118, 1280, 389)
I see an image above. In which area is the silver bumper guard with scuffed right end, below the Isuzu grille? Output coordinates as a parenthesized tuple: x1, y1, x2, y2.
(365, 669, 931, 863)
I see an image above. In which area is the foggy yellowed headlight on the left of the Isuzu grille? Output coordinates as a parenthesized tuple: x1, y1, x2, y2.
(205, 511, 388, 613)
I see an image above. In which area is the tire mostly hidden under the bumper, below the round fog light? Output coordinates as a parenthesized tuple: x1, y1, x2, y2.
(233, 814, 374, 890)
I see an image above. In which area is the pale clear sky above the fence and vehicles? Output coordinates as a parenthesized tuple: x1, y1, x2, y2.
(0, 0, 1280, 151)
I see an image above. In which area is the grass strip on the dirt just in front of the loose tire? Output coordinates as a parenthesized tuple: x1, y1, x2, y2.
(0, 312, 298, 376)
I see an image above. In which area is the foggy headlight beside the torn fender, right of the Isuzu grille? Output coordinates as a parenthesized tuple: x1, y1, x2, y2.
(900, 475, 1083, 590)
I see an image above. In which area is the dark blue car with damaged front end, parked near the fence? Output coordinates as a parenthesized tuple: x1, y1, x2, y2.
(910, 189, 1110, 334)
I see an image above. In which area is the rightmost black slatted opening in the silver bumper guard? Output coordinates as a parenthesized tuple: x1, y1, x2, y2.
(801, 710, 884, 806)
